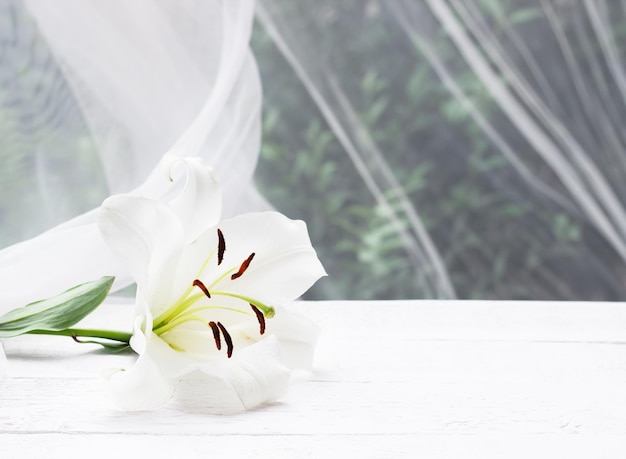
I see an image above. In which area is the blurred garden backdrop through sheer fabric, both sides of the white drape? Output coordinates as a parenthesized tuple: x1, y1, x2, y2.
(0, 0, 626, 300)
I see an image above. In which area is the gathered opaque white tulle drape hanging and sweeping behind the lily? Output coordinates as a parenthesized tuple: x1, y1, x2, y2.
(0, 0, 267, 312)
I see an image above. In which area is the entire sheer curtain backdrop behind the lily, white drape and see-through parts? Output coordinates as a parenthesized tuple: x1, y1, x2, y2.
(0, 0, 626, 307)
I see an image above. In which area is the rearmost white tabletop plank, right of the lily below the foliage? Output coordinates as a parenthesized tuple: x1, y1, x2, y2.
(301, 300, 626, 343)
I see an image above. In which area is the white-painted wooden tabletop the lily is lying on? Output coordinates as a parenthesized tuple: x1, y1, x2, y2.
(0, 301, 626, 459)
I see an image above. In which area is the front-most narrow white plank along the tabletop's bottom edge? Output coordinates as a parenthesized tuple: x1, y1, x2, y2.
(0, 432, 626, 459)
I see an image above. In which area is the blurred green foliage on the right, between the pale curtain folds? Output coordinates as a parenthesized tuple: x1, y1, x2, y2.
(252, 0, 624, 299)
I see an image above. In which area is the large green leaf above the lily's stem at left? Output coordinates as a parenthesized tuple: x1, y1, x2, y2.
(0, 276, 115, 338)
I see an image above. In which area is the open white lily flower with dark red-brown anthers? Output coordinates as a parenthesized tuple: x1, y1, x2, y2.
(98, 155, 325, 410)
